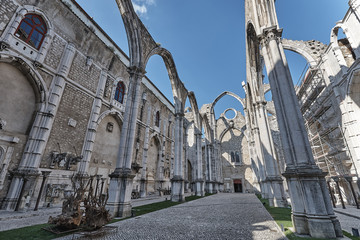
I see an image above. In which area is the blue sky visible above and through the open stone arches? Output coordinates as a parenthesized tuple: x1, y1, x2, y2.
(77, 0, 348, 115)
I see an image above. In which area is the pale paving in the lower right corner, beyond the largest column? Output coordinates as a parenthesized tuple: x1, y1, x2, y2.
(334, 205, 360, 236)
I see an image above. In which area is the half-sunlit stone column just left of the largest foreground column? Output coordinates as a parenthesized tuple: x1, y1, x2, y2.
(255, 101, 287, 207)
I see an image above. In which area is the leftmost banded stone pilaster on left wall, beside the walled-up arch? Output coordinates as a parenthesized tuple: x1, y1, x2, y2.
(2, 43, 75, 210)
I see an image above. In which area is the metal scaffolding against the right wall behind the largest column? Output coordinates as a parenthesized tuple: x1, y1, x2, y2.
(296, 66, 352, 177)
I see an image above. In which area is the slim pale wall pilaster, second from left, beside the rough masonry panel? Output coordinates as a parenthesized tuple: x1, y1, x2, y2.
(78, 70, 107, 175)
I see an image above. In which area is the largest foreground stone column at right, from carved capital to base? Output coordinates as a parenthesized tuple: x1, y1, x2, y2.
(261, 26, 342, 238)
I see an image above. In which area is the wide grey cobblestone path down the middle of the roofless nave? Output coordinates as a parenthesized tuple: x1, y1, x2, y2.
(57, 193, 286, 240)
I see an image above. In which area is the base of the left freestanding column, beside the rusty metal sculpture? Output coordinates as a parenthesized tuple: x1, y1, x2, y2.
(106, 169, 135, 218)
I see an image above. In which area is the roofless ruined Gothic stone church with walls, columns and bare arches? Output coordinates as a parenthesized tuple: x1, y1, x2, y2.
(0, 0, 360, 238)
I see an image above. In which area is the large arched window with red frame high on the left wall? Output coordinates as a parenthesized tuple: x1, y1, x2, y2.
(15, 14, 47, 49)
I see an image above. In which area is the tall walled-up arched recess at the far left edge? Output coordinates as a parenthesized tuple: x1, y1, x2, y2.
(0, 62, 41, 202)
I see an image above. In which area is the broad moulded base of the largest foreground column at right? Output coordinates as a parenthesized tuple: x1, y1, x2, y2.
(283, 165, 342, 239)
